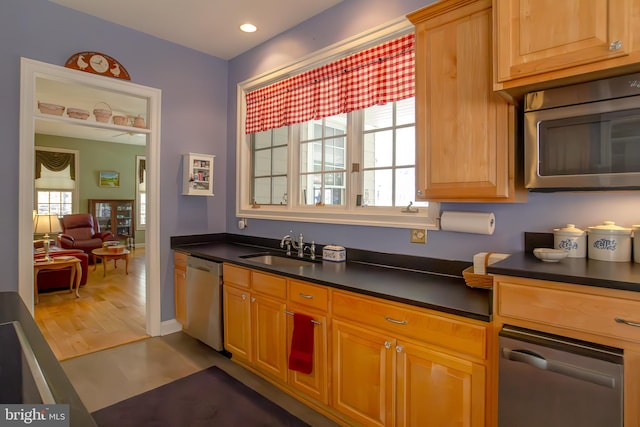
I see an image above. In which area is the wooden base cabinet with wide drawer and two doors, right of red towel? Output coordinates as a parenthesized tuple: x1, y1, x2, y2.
(331, 291, 486, 426)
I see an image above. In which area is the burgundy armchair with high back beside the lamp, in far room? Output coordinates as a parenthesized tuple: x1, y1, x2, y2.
(58, 214, 117, 264)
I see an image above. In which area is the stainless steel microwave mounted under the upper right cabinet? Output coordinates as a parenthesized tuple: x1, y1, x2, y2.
(524, 73, 640, 191)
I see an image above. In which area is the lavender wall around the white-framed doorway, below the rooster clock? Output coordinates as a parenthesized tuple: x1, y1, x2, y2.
(0, 0, 228, 320)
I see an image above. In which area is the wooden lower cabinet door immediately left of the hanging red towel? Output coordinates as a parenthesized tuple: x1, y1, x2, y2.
(251, 295, 288, 382)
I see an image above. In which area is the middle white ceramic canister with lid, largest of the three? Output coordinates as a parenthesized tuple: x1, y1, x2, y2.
(588, 221, 631, 262)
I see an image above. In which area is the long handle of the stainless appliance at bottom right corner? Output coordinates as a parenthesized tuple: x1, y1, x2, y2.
(501, 347, 616, 388)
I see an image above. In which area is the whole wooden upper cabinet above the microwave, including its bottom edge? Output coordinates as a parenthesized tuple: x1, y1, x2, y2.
(493, 0, 640, 94)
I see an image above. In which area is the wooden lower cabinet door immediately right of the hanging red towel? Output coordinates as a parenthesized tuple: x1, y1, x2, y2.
(331, 319, 395, 426)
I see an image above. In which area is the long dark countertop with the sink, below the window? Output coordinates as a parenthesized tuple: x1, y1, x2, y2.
(171, 238, 491, 321)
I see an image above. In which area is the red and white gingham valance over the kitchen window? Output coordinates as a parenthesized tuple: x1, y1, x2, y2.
(246, 34, 415, 134)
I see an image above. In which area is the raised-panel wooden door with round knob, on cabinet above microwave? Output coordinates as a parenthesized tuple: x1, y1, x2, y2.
(494, 0, 632, 82)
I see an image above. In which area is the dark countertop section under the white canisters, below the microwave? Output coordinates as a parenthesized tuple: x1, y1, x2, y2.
(487, 252, 640, 292)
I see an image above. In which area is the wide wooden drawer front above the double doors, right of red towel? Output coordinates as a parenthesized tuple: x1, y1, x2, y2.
(331, 292, 487, 359)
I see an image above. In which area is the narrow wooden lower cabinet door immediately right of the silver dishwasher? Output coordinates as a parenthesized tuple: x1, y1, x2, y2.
(222, 285, 251, 362)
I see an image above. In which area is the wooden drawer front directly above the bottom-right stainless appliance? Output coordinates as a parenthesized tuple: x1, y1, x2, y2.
(498, 282, 640, 342)
